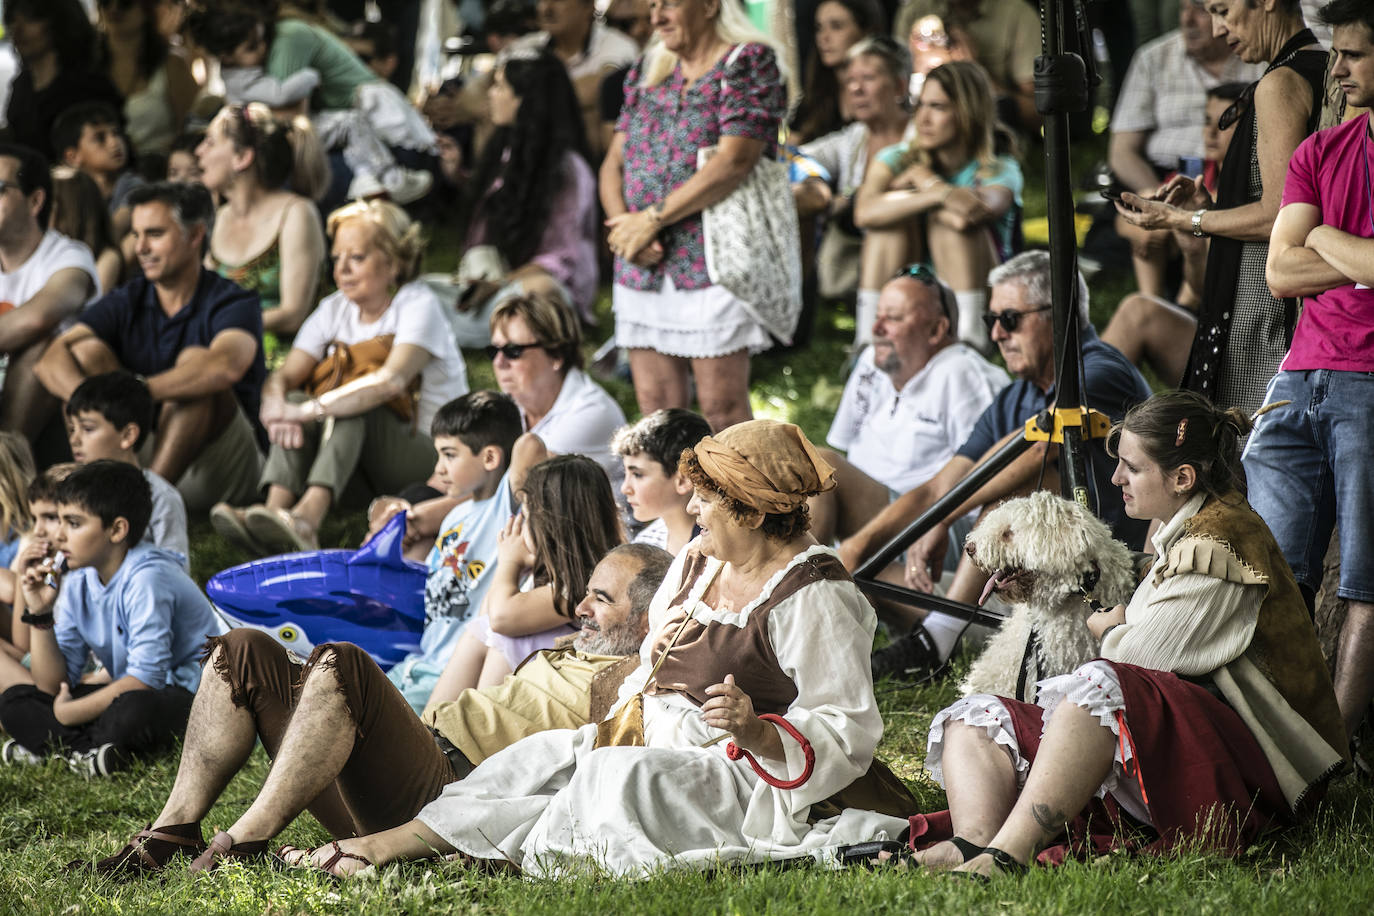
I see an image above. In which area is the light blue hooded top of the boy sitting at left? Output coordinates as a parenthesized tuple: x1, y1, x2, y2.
(54, 544, 224, 692)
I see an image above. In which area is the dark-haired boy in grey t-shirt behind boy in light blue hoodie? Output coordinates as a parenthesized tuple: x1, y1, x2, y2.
(66, 369, 191, 566)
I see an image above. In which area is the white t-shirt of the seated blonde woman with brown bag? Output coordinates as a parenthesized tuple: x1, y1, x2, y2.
(291, 280, 467, 435)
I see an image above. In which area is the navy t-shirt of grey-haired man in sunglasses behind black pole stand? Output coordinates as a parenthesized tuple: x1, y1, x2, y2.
(955, 328, 1150, 551)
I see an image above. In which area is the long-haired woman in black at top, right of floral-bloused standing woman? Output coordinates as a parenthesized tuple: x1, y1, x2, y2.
(789, 0, 884, 144)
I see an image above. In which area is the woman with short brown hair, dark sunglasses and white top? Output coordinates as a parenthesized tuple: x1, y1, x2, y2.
(486, 295, 625, 492)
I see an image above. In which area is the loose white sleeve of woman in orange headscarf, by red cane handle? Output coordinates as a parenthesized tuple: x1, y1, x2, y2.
(756, 580, 882, 817)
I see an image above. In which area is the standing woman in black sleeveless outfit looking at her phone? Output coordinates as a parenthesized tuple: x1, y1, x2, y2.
(1117, 0, 1326, 413)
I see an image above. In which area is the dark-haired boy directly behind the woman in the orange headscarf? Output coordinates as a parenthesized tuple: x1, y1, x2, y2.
(610, 407, 710, 556)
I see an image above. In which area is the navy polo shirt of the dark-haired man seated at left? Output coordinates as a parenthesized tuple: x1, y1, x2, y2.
(80, 266, 267, 427)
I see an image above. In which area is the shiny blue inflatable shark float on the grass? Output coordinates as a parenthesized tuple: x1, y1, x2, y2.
(205, 512, 427, 670)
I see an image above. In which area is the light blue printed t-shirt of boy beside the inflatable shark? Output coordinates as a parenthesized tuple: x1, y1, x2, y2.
(386, 472, 515, 711)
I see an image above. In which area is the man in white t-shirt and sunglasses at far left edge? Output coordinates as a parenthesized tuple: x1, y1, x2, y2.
(0, 144, 100, 457)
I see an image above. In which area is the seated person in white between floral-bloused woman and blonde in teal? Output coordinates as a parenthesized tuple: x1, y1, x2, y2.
(793, 35, 911, 329)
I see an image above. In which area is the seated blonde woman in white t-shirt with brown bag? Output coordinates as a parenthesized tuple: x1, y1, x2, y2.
(210, 201, 467, 555)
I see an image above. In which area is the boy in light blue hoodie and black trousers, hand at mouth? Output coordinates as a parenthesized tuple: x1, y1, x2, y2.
(0, 461, 223, 776)
